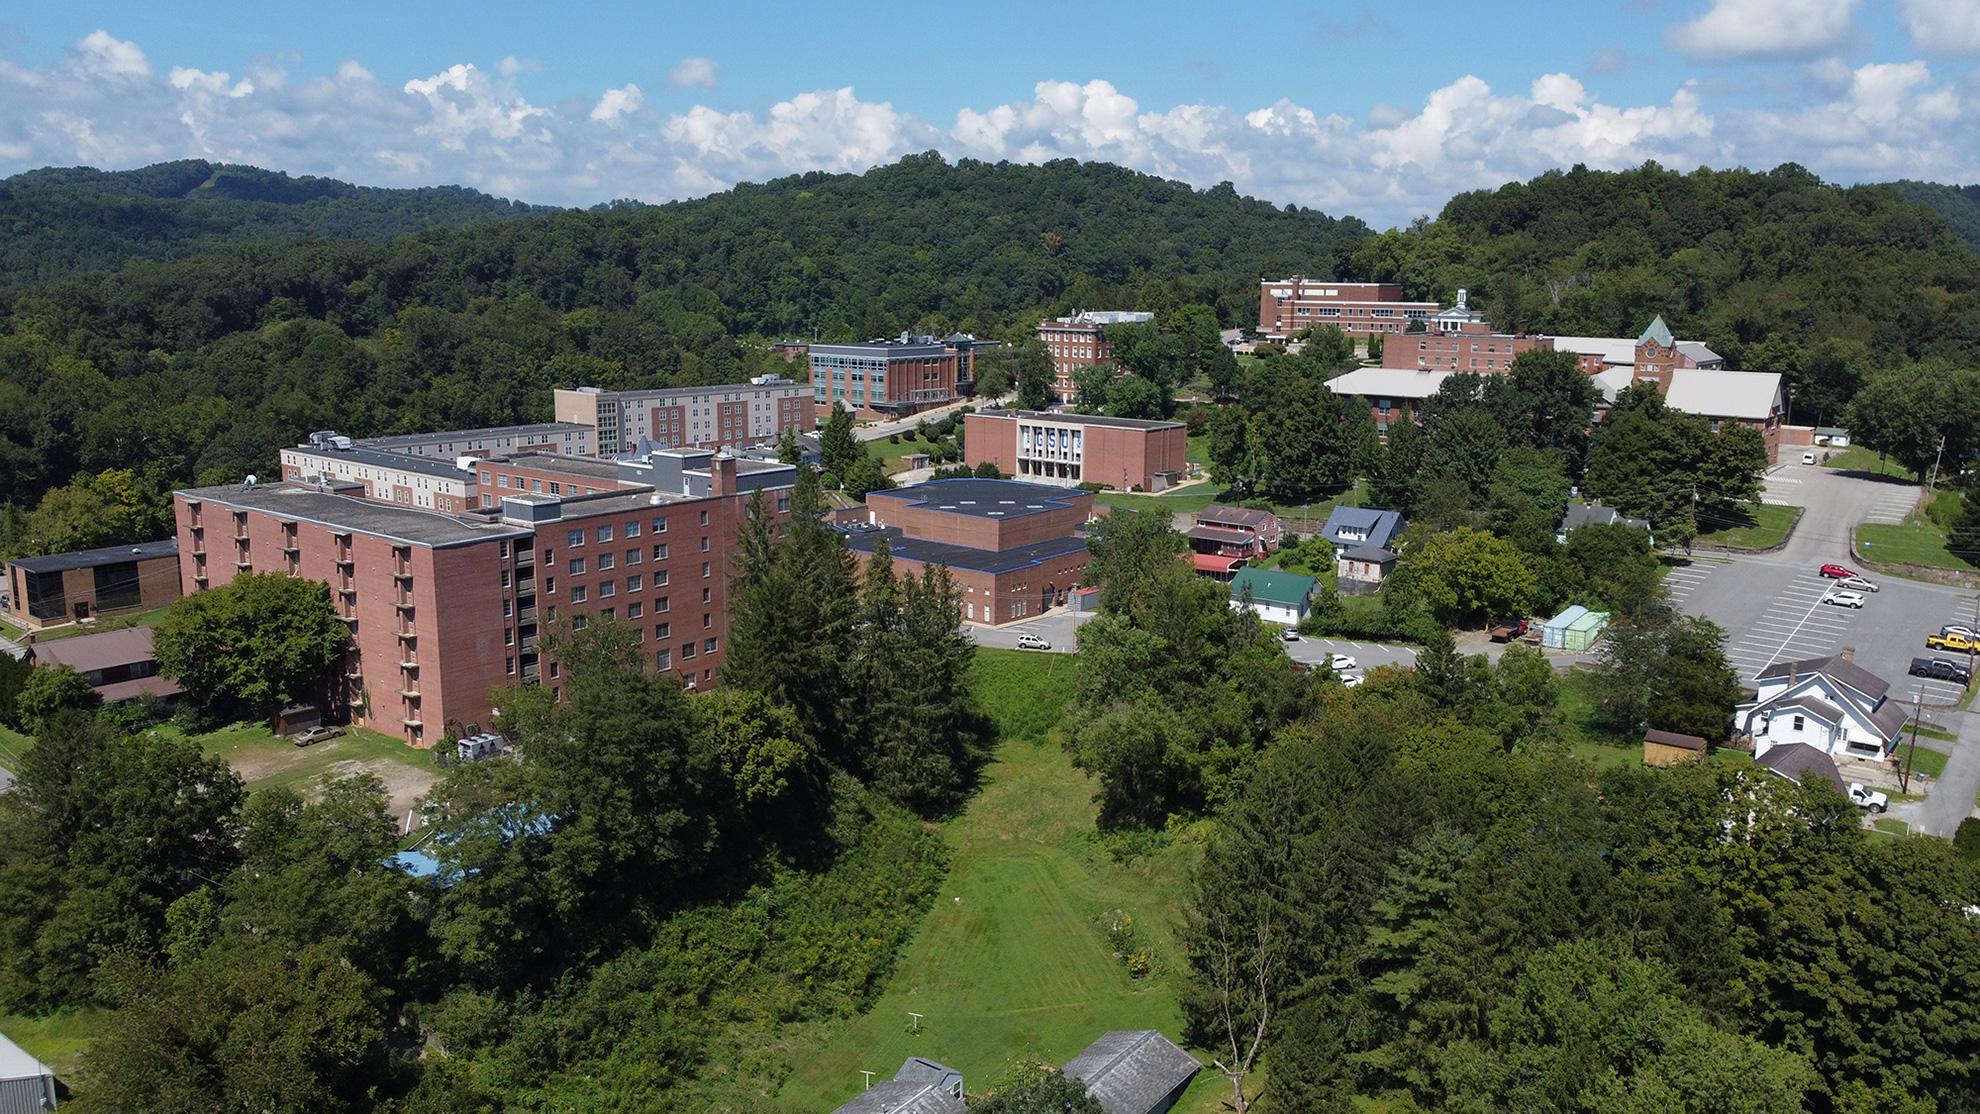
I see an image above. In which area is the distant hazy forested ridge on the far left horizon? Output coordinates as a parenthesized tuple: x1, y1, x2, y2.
(0, 158, 545, 285)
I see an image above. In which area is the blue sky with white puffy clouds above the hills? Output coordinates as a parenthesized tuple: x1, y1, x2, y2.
(0, 0, 1980, 224)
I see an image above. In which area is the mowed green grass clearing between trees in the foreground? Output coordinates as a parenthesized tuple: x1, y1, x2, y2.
(780, 649, 1228, 1114)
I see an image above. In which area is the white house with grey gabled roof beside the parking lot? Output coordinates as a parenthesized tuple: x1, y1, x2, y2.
(1733, 655, 1905, 758)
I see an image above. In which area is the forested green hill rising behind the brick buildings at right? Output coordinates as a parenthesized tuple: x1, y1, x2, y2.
(1352, 164, 1980, 380)
